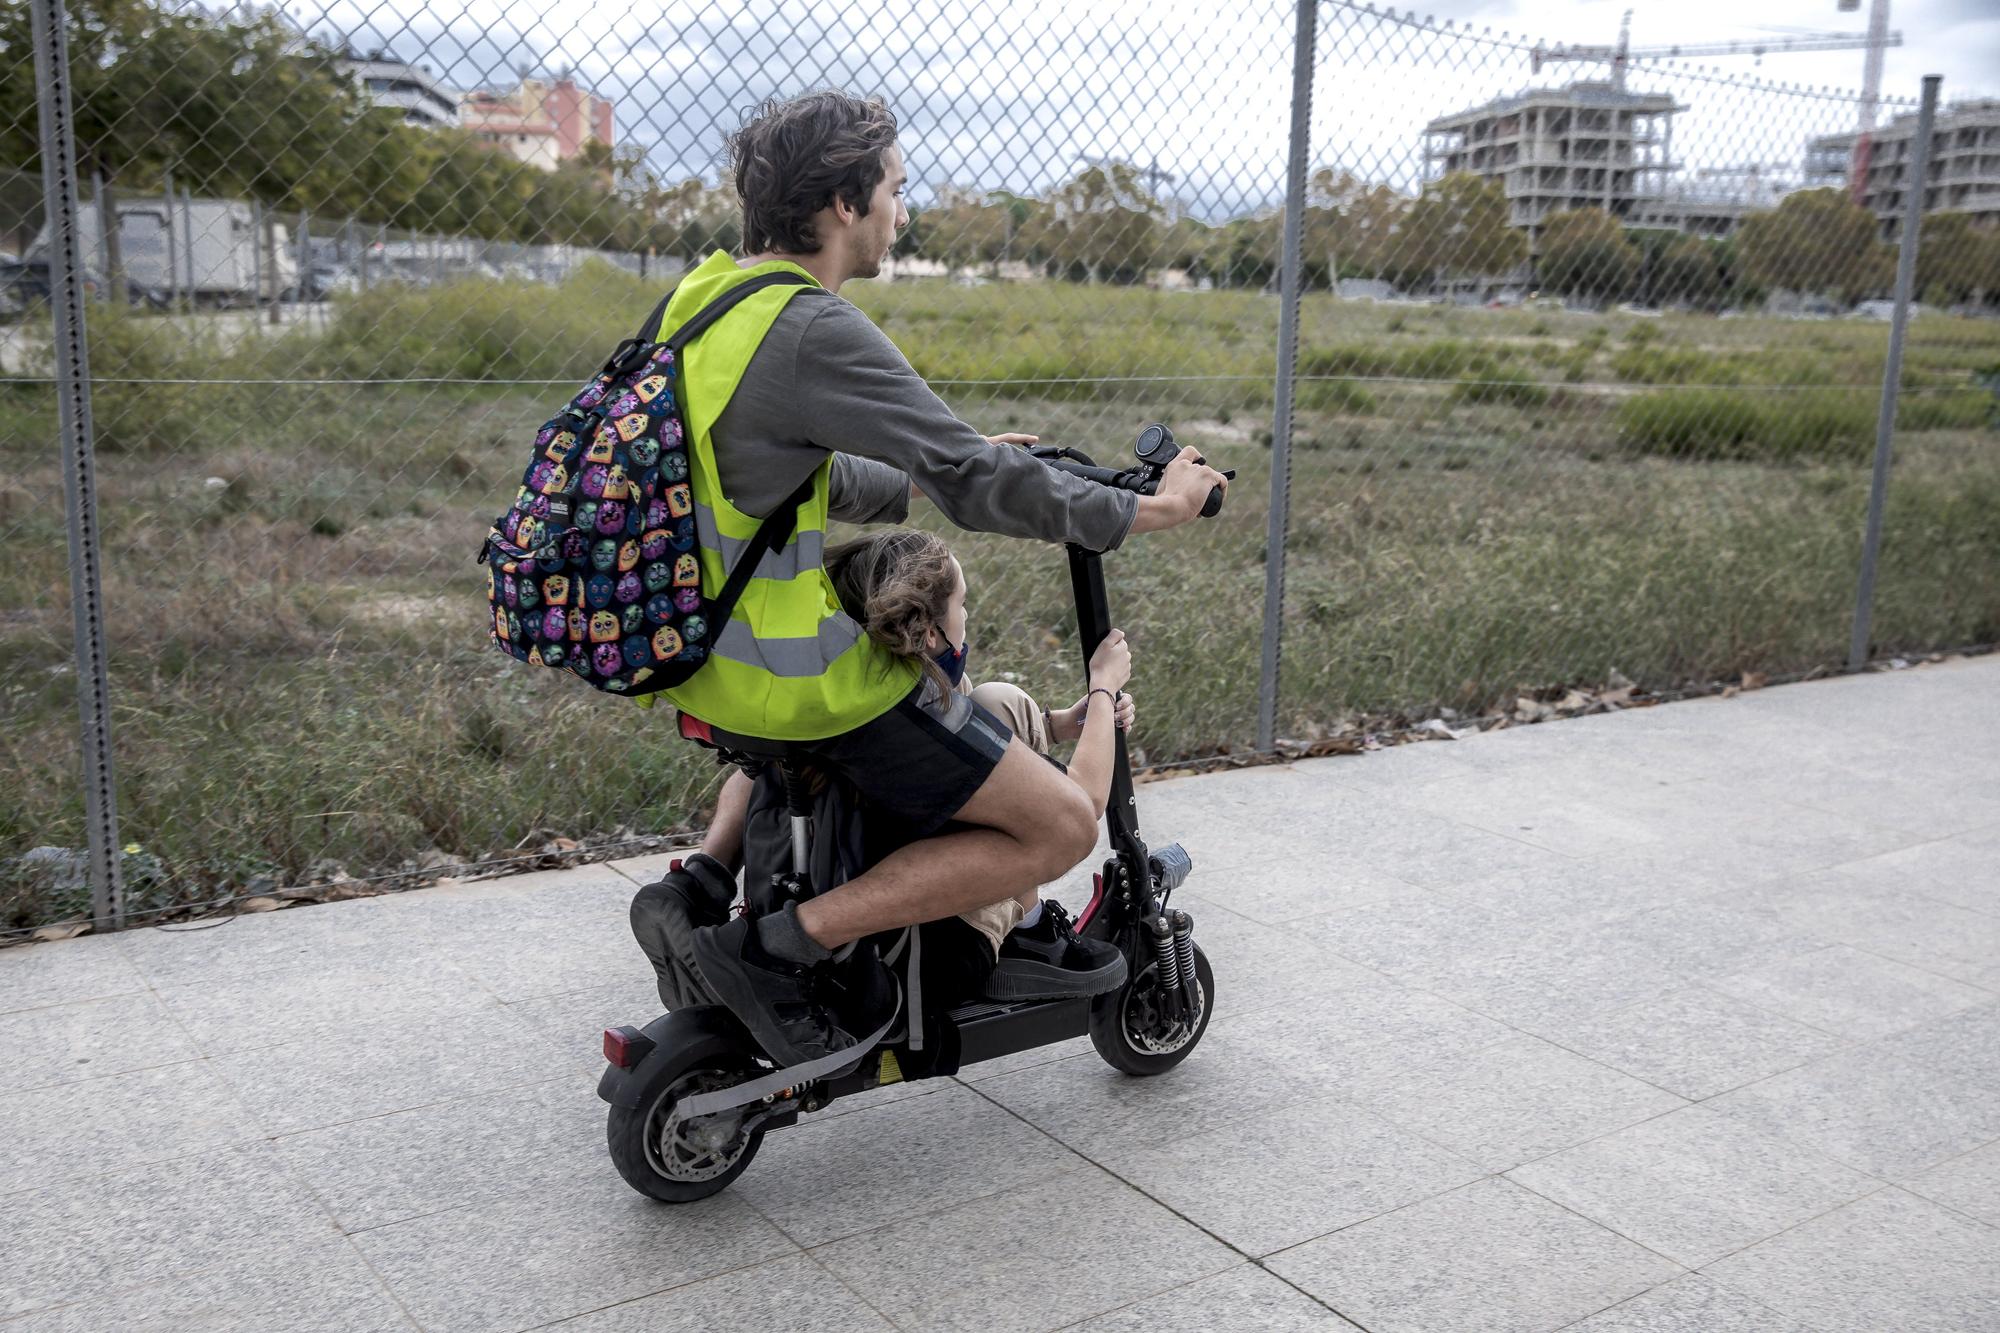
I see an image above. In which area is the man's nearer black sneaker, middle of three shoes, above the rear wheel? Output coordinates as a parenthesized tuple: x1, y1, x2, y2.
(694, 917, 896, 1067)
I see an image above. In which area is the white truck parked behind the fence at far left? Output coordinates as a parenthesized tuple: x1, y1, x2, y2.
(30, 196, 298, 304)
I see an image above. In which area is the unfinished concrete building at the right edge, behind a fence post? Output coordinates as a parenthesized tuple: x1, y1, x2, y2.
(1806, 98, 2000, 240)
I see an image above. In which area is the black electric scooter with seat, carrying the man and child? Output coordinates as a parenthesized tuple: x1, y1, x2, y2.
(598, 424, 1234, 1203)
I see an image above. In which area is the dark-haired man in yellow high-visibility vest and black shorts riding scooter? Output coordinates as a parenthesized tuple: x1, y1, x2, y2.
(634, 92, 1228, 1065)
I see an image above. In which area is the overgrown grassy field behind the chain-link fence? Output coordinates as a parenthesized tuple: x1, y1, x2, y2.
(0, 270, 2000, 927)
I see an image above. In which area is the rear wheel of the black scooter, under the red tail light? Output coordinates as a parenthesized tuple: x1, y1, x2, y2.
(604, 1053, 764, 1203)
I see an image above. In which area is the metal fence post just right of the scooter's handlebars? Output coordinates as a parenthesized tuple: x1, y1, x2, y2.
(1256, 0, 1318, 753)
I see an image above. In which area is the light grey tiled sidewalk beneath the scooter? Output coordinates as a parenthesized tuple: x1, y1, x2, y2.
(0, 656, 2000, 1333)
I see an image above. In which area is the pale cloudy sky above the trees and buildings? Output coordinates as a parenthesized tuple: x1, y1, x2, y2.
(300, 0, 2000, 218)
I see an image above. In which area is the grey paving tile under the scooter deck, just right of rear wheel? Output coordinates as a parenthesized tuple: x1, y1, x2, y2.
(734, 1083, 1080, 1247)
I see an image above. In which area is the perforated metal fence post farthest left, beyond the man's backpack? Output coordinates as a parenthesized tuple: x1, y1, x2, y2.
(28, 0, 124, 929)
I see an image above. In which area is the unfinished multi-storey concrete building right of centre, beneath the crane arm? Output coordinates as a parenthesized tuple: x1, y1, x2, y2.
(1424, 82, 1684, 252)
